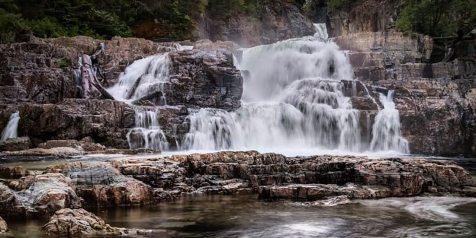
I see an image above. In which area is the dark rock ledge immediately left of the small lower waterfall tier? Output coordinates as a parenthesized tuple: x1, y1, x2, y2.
(18, 99, 134, 148)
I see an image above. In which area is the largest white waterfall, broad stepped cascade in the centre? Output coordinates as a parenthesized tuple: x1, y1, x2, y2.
(182, 38, 362, 151)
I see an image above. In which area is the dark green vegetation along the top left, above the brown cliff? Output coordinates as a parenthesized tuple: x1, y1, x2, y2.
(0, 0, 274, 43)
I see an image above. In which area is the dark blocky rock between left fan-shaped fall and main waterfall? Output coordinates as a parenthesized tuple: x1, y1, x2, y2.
(165, 45, 243, 110)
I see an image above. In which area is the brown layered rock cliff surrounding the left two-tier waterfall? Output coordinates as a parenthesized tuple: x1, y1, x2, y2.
(0, 37, 243, 149)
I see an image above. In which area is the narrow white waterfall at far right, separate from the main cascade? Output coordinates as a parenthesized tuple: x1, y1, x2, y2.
(370, 91, 410, 154)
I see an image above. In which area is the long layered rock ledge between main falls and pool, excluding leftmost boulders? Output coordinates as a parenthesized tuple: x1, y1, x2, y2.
(32, 152, 476, 205)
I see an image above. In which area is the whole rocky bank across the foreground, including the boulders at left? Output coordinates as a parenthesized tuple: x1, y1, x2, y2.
(0, 151, 476, 233)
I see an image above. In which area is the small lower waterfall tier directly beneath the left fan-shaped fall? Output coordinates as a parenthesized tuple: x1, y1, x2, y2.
(127, 107, 169, 151)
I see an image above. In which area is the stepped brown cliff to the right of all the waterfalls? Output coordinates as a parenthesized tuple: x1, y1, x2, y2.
(336, 32, 476, 156)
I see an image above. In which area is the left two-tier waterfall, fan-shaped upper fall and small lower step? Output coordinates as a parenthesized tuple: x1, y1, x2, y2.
(108, 44, 181, 151)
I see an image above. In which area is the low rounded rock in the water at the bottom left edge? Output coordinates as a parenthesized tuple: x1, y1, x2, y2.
(43, 208, 121, 236)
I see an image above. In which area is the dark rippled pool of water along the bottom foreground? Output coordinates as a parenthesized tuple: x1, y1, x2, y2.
(2, 195, 476, 238)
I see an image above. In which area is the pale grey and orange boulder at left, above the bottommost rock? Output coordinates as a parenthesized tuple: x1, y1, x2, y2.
(15, 173, 83, 215)
